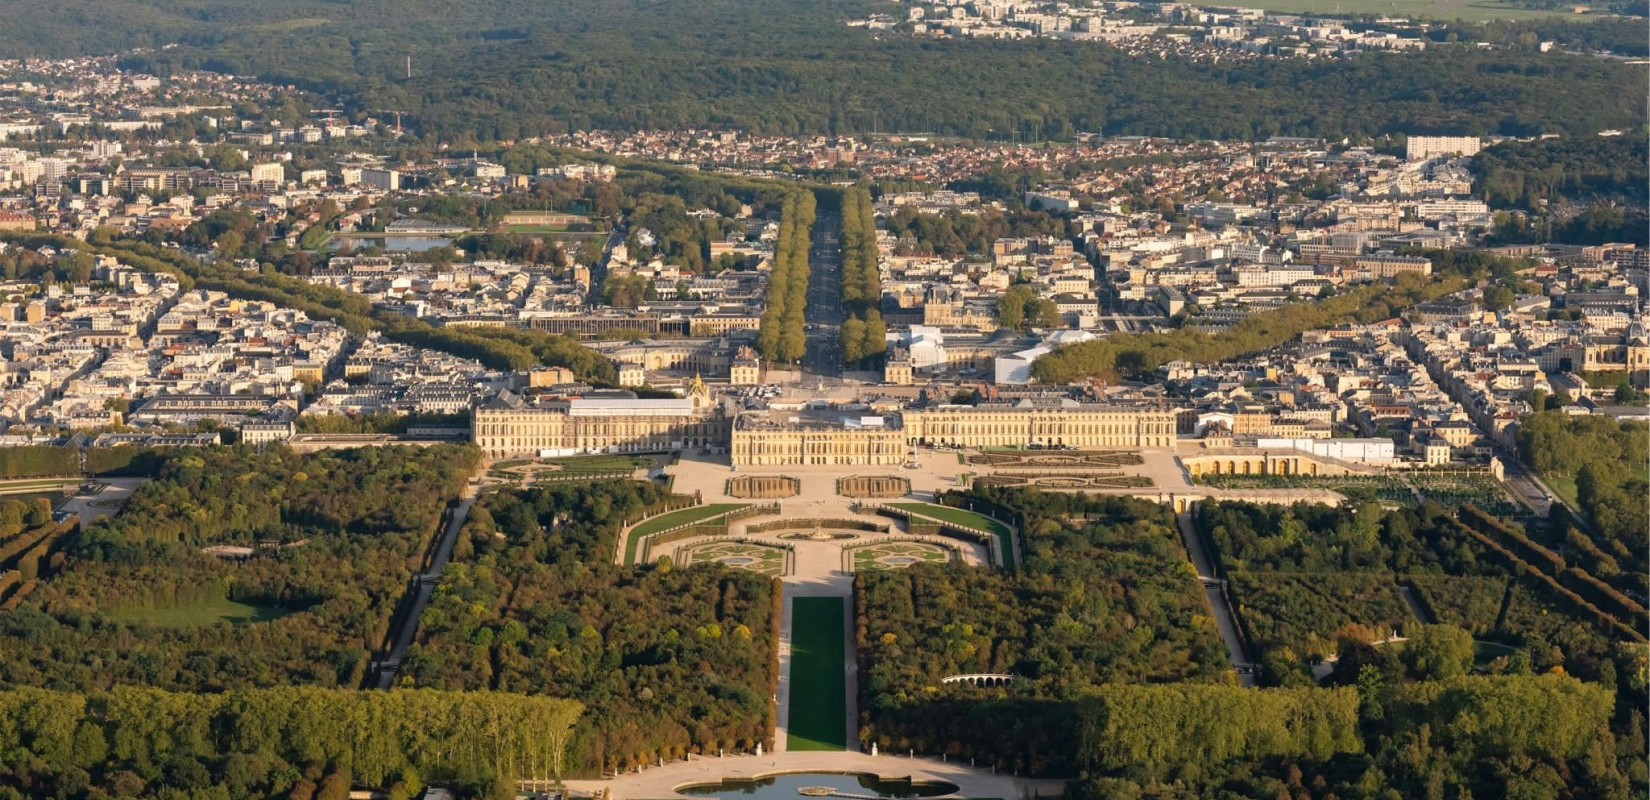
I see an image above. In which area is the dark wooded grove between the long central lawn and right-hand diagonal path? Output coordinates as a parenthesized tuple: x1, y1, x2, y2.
(855, 490, 1229, 774)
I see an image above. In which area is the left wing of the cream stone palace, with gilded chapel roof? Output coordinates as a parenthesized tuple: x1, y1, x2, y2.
(470, 379, 728, 459)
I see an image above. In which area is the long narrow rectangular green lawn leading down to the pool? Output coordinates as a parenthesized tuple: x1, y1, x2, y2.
(785, 597, 848, 751)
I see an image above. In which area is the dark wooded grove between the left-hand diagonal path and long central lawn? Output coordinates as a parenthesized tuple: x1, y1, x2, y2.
(399, 482, 779, 775)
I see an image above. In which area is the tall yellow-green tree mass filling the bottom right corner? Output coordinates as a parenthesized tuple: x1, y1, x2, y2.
(1056, 666, 1645, 800)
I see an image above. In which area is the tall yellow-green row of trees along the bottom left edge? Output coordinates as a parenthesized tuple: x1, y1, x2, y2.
(0, 686, 581, 800)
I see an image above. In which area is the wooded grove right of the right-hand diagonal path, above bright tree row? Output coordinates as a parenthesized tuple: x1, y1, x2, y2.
(1198, 503, 1643, 685)
